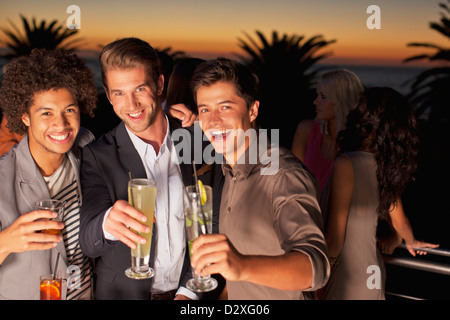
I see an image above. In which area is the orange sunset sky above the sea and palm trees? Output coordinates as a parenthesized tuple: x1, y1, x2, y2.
(0, 0, 447, 64)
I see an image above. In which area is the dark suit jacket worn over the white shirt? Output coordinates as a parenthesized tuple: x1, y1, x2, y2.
(80, 118, 223, 299)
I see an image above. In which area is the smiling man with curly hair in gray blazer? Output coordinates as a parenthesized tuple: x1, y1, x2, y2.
(0, 49, 97, 299)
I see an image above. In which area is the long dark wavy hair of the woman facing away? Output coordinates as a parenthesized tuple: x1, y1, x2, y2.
(337, 87, 419, 217)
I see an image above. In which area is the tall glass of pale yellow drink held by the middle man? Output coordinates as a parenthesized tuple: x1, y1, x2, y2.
(125, 179, 156, 279)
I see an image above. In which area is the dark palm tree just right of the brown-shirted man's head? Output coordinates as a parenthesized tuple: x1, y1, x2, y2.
(237, 31, 335, 148)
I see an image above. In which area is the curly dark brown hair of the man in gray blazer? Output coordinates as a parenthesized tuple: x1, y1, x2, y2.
(0, 49, 97, 135)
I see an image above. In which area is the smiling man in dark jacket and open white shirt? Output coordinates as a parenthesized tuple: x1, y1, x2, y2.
(80, 38, 222, 300)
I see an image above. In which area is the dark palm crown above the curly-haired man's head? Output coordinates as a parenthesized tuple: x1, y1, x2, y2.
(0, 15, 82, 59)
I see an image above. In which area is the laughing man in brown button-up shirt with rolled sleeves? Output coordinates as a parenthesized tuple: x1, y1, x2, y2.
(191, 59, 329, 300)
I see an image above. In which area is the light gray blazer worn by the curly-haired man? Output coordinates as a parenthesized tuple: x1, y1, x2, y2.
(0, 128, 94, 300)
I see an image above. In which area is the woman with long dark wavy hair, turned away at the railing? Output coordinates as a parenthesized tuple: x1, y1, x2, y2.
(322, 88, 437, 299)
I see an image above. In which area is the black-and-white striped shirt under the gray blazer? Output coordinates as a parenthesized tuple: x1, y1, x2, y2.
(53, 180, 91, 300)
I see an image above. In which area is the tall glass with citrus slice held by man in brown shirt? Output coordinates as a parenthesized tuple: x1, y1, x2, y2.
(184, 181, 217, 292)
